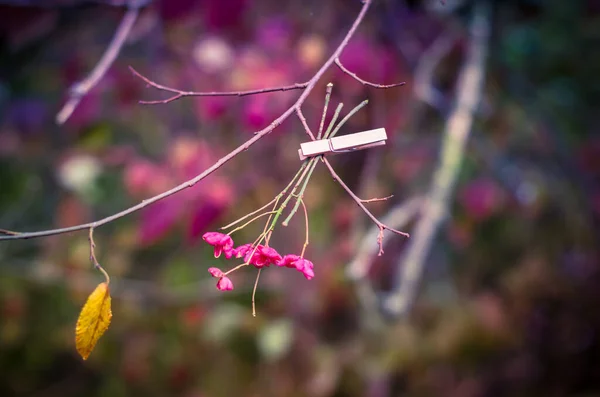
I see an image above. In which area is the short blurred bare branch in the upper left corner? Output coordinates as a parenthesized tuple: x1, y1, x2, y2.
(56, 6, 139, 124)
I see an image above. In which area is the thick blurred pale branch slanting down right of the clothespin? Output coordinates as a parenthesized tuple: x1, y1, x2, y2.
(383, 1, 490, 316)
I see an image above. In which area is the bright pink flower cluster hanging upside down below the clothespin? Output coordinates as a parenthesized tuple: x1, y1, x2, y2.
(202, 232, 315, 291)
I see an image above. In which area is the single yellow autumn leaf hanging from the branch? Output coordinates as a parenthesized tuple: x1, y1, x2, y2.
(75, 283, 112, 360)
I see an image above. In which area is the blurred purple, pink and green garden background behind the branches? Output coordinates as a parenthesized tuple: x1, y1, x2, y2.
(0, 0, 600, 397)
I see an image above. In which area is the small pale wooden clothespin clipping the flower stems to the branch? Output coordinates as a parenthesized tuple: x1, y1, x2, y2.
(298, 128, 387, 160)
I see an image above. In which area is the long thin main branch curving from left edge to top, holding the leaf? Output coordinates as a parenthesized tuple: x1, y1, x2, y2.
(0, 0, 372, 240)
